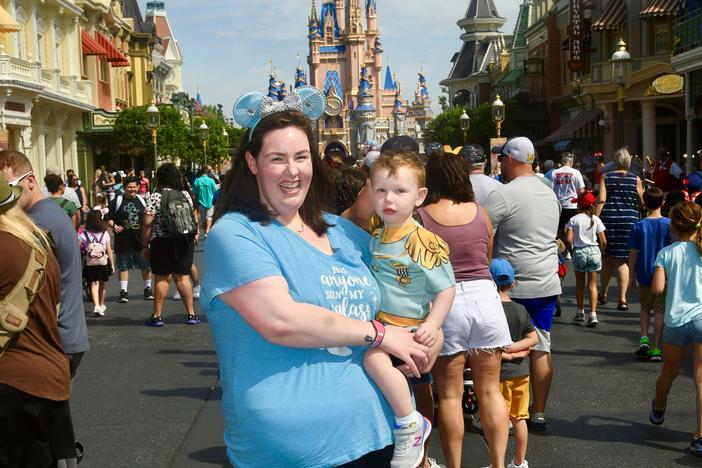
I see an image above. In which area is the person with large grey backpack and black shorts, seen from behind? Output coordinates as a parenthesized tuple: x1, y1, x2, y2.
(141, 163, 200, 327)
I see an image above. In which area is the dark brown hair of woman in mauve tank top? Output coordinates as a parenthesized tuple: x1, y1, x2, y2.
(424, 151, 475, 206)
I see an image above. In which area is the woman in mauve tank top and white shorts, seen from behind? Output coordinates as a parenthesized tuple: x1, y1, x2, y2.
(419, 145, 512, 467)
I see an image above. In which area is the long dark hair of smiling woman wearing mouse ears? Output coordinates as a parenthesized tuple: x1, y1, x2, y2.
(214, 111, 332, 235)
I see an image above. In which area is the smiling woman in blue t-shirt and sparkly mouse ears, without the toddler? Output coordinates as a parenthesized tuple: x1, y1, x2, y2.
(201, 88, 432, 467)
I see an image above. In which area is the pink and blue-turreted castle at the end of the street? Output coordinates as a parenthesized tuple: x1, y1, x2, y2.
(268, 0, 433, 157)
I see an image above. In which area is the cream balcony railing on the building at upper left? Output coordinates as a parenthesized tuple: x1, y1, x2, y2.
(0, 53, 92, 104)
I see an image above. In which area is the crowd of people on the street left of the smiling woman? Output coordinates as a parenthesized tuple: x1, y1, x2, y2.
(0, 151, 226, 468)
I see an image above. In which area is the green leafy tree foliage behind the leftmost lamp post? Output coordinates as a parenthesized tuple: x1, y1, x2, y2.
(113, 105, 194, 166)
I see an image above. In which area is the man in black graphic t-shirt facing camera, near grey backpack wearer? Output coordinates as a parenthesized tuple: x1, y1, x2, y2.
(106, 177, 154, 304)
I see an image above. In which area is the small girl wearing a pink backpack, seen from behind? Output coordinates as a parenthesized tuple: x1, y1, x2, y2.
(78, 210, 115, 317)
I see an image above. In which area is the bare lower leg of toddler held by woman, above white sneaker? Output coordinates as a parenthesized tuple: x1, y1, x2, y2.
(363, 348, 414, 418)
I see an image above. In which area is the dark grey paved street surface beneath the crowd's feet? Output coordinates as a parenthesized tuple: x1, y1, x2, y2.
(72, 247, 702, 468)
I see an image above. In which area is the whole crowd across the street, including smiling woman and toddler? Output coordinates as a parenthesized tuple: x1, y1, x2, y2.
(0, 85, 702, 468)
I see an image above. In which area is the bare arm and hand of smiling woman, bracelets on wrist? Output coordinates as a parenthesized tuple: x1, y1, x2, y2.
(219, 276, 429, 377)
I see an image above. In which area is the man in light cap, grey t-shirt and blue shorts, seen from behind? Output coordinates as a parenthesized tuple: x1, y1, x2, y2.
(485, 137, 561, 429)
